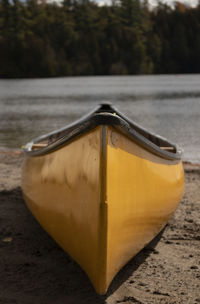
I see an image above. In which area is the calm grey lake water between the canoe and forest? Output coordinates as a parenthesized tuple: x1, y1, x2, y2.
(0, 75, 200, 163)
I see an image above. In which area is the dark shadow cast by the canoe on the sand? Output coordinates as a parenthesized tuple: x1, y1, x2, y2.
(0, 188, 162, 304)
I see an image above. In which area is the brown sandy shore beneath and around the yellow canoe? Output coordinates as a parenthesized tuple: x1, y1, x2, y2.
(0, 152, 200, 304)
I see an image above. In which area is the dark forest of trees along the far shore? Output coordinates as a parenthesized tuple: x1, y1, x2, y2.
(0, 0, 200, 78)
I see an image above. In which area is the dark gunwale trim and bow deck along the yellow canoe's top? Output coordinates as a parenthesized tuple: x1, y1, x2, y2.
(24, 104, 182, 160)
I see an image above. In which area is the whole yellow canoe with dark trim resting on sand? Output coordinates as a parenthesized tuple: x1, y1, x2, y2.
(22, 105, 184, 294)
